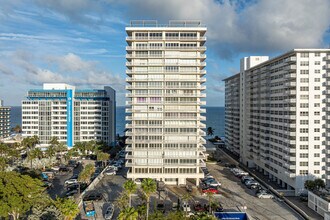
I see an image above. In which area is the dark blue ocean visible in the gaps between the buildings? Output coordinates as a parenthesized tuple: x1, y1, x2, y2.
(10, 106, 225, 137)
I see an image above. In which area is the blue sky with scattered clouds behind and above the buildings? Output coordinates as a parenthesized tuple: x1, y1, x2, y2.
(0, 0, 330, 106)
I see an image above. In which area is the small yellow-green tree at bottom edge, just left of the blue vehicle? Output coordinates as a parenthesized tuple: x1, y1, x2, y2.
(54, 197, 80, 220)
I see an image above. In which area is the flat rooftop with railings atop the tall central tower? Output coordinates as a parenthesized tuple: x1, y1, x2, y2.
(129, 20, 206, 28)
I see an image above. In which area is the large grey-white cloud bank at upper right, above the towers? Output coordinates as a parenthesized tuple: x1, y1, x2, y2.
(117, 0, 330, 59)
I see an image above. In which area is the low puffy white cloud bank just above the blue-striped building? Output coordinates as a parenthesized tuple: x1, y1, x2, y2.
(0, 51, 125, 92)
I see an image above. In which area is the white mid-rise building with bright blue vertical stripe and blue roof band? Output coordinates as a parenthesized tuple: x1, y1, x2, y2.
(22, 83, 116, 148)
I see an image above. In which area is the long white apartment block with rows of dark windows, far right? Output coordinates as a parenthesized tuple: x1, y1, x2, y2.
(224, 49, 330, 194)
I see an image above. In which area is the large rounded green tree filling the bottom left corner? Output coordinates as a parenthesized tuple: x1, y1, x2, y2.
(0, 172, 47, 220)
